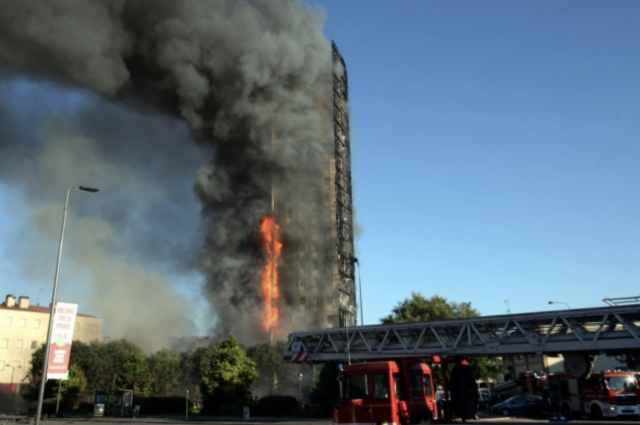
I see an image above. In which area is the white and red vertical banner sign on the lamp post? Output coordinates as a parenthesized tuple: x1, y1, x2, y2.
(47, 303, 78, 380)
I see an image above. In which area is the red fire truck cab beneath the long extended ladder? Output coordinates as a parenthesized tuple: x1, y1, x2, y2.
(333, 360, 438, 425)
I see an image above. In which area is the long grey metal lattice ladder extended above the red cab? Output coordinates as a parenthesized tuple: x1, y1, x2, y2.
(283, 304, 640, 363)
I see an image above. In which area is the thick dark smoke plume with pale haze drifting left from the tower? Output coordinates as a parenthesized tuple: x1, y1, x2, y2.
(0, 0, 332, 351)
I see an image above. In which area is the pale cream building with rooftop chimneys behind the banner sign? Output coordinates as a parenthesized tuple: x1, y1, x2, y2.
(0, 295, 103, 393)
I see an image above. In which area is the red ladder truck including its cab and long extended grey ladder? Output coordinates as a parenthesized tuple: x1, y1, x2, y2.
(283, 297, 640, 425)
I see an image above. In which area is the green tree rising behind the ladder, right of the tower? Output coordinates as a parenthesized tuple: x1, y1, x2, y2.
(382, 292, 507, 383)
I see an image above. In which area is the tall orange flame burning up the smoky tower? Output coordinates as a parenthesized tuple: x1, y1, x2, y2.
(260, 216, 282, 332)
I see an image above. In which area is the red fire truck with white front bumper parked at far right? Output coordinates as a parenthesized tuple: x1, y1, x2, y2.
(549, 371, 640, 419)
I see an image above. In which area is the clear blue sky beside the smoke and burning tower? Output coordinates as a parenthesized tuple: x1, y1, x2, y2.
(0, 0, 640, 330)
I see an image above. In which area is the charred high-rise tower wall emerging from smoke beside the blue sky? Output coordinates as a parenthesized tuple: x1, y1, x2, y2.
(277, 43, 357, 330)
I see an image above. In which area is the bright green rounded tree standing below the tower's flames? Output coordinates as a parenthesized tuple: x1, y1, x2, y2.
(200, 335, 258, 414)
